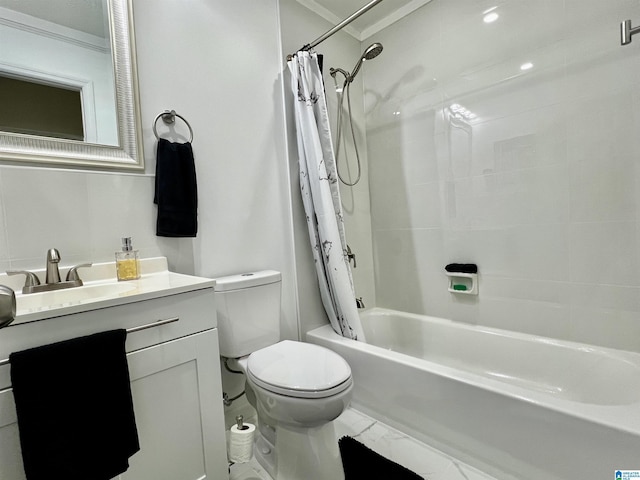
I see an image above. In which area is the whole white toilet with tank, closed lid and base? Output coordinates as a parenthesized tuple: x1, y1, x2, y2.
(215, 270, 353, 480)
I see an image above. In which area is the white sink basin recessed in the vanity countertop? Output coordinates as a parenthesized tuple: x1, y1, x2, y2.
(16, 282, 136, 315)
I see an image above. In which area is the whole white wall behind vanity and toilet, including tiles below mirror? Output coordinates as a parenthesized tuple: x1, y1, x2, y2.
(0, 0, 298, 344)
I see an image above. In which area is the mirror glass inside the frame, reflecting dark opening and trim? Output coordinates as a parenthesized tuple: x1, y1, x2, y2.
(0, 0, 118, 146)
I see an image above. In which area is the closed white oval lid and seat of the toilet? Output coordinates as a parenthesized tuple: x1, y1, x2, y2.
(247, 340, 351, 398)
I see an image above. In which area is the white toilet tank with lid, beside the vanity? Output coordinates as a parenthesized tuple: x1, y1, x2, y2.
(215, 270, 281, 358)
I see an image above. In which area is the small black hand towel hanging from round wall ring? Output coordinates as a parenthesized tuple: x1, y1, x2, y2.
(153, 138, 198, 237)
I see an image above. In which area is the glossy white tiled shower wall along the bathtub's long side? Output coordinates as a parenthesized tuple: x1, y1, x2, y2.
(362, 0, 640, 351)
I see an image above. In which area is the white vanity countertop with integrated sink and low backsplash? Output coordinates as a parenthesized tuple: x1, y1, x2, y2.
(0, 257, 215, 325)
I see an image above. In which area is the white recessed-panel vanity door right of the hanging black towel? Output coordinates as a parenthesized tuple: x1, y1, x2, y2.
(120, 329, 228, 480)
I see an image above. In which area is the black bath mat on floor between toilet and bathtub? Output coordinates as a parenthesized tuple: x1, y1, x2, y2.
(338, 437, 424, 480)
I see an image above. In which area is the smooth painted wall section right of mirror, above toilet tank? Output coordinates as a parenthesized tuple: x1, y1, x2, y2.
(134, 0, 297, 344)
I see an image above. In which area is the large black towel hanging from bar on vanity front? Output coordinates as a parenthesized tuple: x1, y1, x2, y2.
(9, 330, 140, 480)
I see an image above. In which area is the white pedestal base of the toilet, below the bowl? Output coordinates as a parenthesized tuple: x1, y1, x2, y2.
(254, 422, 344, 480)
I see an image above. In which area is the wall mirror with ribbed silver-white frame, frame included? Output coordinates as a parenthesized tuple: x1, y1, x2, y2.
(0, 0, 144, 170)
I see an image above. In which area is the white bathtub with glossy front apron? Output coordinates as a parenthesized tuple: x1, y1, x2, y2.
(307, 308, 640, 480)
